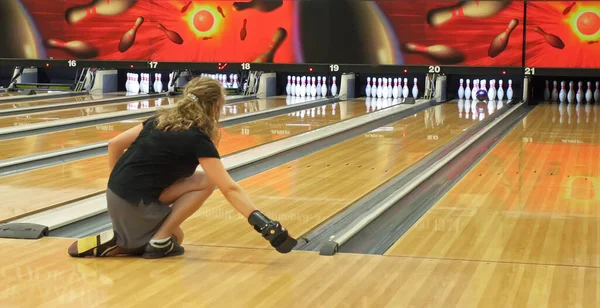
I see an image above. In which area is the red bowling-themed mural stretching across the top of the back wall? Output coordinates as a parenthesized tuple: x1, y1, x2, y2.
(9, 0, 600, 67)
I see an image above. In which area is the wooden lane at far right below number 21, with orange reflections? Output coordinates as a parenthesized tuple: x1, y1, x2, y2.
(387, 104, 600, 268)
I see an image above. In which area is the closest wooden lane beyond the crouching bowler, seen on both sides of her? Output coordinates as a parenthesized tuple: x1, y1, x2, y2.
(0, 99, 384, 221)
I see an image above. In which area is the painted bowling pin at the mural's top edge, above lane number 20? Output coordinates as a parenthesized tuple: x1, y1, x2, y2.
(427, 0, 512, 27)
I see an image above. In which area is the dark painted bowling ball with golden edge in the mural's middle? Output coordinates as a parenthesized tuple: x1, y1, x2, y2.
(294, 0, 404, 64)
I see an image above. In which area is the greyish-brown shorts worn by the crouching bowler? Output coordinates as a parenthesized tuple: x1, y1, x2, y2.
(106, 188, 171, 249)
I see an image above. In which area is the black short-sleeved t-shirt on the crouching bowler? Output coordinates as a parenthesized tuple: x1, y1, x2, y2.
(108, 117, 220, 204)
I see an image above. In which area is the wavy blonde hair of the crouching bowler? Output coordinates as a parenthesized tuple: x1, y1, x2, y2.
(156, 77, 225, 144)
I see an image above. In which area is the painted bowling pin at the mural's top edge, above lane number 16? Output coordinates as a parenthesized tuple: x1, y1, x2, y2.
(65, 0, 138, 24)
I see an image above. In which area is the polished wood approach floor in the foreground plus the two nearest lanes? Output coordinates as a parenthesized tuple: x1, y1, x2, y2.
(0, 102, 600, 307)
